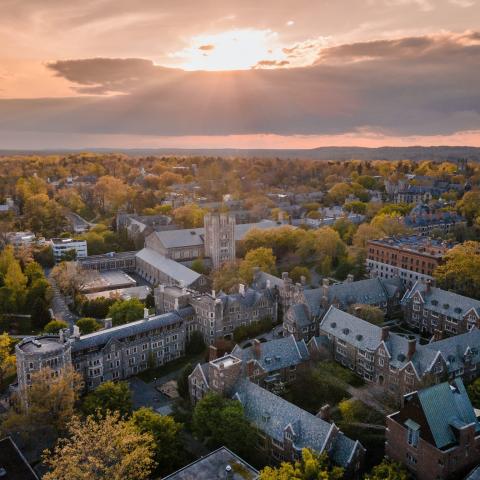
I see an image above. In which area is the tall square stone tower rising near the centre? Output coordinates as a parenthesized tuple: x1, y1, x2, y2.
(204, 213, 235, 268)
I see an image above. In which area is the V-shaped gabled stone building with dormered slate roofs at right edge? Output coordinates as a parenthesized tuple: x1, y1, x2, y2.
(320, 306, 480, 401)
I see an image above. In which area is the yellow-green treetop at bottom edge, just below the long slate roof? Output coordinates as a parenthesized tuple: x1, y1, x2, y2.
(260, 448, 344, 480)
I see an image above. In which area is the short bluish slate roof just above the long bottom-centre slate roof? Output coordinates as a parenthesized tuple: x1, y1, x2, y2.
(232, 335, 310, 372)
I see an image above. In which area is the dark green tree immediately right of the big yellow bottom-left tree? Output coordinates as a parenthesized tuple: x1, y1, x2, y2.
(131, 407, 182, 472)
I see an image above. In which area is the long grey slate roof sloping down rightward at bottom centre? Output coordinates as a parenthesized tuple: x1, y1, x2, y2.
(234, 380, 359, 467)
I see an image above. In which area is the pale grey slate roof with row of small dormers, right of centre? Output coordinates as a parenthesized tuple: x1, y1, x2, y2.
(320, 306, 382, 351)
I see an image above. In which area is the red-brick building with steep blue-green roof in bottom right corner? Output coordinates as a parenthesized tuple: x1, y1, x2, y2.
(385, 379, 480, 480)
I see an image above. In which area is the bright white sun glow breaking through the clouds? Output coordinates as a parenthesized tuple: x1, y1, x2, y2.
(171, 29, 285, 70)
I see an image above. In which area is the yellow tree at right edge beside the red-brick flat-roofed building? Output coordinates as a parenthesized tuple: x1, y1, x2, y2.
(433, 241, 480, 298)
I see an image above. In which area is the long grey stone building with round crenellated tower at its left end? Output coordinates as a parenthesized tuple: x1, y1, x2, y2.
(15, 307, 194, 390)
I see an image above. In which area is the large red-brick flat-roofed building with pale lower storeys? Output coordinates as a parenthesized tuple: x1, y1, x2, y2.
(367, 235, 452, 285)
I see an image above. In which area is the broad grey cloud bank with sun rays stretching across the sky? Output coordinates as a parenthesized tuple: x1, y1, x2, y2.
(0, 33, 480, 140)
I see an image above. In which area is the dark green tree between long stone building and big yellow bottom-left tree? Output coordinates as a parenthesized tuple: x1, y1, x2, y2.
(82, 381, 133, 417)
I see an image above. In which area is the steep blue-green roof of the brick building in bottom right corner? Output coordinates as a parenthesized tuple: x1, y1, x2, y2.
(417, 378, 480, 448)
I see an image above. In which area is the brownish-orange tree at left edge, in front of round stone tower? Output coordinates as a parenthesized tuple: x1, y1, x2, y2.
(1, 366, 83, 439)
